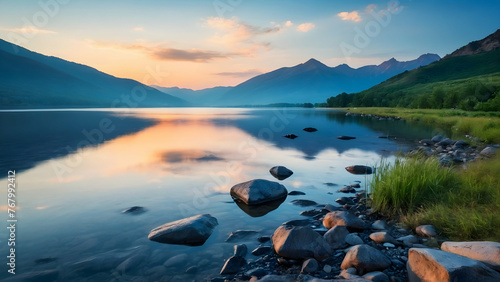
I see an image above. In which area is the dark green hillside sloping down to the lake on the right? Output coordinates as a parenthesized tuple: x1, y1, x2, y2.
(327, 50, 500, 111)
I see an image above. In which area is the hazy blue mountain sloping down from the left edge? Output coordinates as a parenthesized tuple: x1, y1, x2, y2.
(0, 39, 188, 109)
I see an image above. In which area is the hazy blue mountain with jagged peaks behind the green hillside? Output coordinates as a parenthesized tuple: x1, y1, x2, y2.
(217, 54, 440, 106)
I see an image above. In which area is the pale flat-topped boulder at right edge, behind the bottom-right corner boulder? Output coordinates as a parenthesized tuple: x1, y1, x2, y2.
(441, 241, 500, 272)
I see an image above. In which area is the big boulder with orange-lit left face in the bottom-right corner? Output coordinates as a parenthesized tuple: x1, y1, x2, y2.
(406, 248, 500, 282)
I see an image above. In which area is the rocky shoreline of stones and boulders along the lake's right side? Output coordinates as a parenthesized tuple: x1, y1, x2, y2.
(207, 113, 500, 281)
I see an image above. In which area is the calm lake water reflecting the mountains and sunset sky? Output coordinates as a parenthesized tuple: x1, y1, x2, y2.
(0, 108, 434, 281)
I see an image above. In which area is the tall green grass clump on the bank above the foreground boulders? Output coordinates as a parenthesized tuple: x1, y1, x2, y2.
(372, 156, 500, 241)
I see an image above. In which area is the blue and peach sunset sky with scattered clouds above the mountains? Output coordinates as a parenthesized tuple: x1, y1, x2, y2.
(0, 0, 500, 90)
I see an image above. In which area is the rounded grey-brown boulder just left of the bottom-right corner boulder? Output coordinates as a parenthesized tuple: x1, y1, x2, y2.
(340, 244, 391, 275)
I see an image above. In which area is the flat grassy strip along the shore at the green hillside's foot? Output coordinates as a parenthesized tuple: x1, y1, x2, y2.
(347, 108, 500, 144)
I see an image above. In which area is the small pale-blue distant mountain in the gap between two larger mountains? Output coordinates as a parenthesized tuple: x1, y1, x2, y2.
(150, 85, 233, 106)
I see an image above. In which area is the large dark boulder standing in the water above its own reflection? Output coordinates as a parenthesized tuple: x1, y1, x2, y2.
(231, 179, 288, 205)
